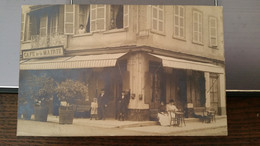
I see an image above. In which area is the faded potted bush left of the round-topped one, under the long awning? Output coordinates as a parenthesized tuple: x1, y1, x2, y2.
(33, 75, 55, 122)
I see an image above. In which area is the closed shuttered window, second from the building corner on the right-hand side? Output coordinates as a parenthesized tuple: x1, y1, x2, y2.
(173, 6, 185, 39)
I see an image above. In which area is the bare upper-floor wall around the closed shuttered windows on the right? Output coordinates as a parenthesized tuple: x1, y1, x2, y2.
(137, 6, 224, 60)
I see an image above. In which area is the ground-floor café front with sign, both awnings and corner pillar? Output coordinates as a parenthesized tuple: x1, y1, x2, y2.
(20, 47, 225, 121)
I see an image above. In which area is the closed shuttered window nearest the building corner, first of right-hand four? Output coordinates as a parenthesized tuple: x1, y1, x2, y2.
(152, 5, 164, 33)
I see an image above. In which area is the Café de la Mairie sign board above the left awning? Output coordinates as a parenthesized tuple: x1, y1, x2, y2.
(23, 46, 64, 59)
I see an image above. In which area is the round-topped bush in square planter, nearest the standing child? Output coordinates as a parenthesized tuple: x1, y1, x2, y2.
(56, 79, 88, 124)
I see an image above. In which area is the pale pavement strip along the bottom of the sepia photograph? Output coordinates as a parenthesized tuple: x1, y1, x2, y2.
(17, 115, 227, 136)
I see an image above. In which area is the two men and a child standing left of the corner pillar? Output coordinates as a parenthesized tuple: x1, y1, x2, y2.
(90, 89, 129, 121)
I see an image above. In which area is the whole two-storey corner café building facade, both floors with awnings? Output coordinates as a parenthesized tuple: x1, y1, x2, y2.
(20, 5, 226, 120)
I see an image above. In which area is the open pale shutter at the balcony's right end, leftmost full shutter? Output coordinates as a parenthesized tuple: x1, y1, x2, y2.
(64, 5, 75, 35)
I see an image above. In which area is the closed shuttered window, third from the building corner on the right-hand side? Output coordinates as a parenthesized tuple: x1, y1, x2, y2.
(193, 10, 203, 44)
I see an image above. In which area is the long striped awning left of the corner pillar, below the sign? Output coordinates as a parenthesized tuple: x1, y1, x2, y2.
(20, 53, 126, 70)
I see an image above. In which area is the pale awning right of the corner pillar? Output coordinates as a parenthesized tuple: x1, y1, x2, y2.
(149, 53, 224, 73)
